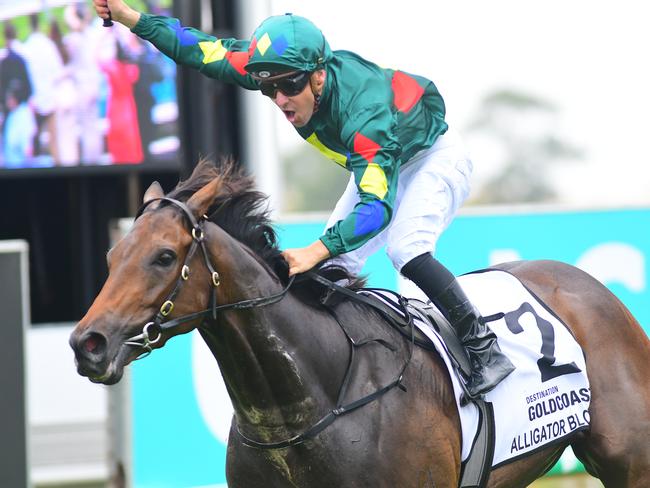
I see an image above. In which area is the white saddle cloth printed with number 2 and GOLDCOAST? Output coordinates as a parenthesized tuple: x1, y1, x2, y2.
(364, 270, 591, 468)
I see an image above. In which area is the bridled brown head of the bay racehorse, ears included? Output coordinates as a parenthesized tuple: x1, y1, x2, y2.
(70, 167, 222, 384)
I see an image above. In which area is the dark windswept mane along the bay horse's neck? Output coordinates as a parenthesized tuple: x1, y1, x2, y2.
(167, 158, 365, 298)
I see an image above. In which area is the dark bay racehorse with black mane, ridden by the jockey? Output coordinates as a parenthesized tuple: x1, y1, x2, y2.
(70, 160, 650, 488)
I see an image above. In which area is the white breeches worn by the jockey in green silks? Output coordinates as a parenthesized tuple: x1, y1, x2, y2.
(326, 130, 472, 274)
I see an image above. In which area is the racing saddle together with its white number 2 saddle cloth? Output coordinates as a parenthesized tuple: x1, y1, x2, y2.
(308, 269, 591, 488)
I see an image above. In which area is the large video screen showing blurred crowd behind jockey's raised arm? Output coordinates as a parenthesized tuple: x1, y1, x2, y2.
(0, 0, 179, 169)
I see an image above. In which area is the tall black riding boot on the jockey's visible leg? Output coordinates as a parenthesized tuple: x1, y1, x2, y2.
(402, 253, 515, 399)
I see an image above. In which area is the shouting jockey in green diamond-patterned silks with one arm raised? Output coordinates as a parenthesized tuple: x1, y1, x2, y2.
(94, 0, 514, 398)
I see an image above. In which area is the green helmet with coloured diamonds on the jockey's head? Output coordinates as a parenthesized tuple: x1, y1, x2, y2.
(244, 14, 332, 79)
